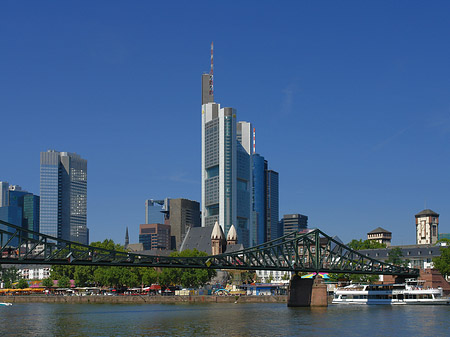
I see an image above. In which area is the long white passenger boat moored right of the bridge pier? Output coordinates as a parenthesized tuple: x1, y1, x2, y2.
(332, 279, 450, 304)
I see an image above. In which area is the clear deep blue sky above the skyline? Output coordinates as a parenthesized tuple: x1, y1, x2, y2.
(0, 1, 450, 244)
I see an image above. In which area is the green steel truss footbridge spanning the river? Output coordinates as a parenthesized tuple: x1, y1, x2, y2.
(0, 220, 419, 277)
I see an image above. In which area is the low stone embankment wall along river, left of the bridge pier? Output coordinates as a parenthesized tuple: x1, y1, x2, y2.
(0, 295, 287, 304)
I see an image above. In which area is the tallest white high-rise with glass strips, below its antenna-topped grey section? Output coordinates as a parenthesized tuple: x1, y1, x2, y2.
(202, 102, 253, 246)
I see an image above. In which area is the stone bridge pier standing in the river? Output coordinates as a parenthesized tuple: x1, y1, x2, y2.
(287, 275, 328, 307)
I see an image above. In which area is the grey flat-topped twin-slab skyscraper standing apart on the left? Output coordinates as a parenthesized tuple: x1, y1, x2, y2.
(40, 150, 89, 244)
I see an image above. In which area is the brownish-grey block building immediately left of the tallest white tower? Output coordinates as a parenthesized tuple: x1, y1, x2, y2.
(169, 198, 201, 250)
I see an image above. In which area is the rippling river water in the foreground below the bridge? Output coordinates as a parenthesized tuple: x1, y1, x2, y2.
(0, 303, 450, 336)
